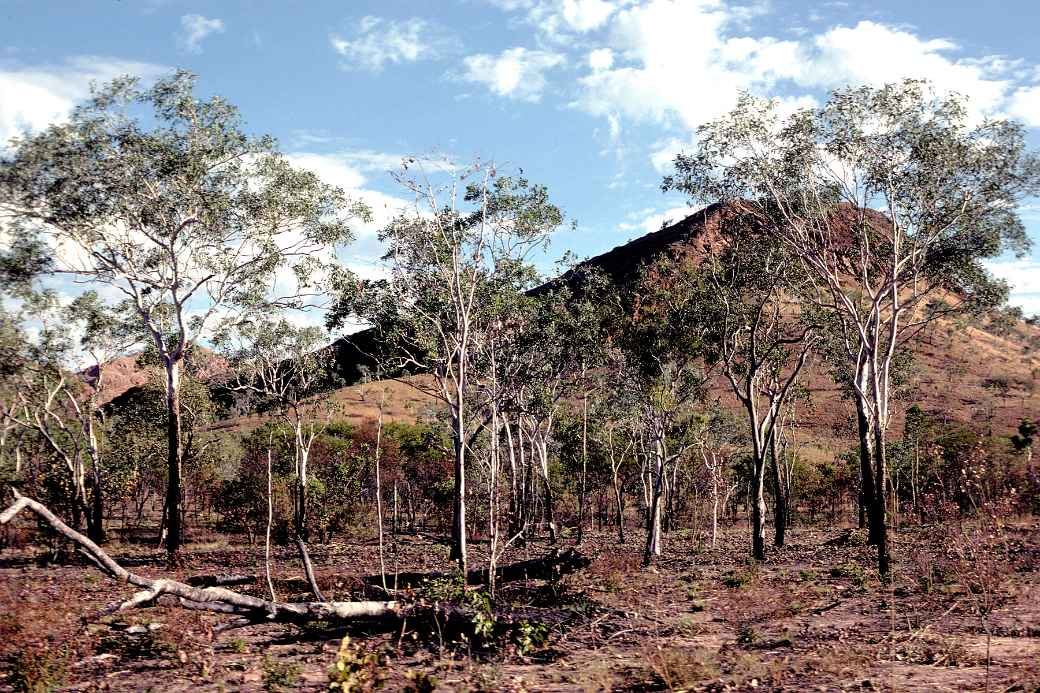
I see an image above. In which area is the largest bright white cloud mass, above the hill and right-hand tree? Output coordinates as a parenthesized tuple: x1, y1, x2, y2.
(574, 0, 1040, 146)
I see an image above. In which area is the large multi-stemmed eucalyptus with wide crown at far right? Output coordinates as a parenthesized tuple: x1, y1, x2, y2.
(664, 81, 1040, 576)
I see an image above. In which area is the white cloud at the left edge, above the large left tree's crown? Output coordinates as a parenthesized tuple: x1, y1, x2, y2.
(0, 56, 166, 149)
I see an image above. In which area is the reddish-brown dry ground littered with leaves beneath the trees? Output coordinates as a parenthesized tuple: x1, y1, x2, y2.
(0, 521, 1040, 691)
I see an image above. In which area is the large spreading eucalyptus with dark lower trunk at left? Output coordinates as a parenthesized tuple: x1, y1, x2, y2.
(0, 71, 367, 557)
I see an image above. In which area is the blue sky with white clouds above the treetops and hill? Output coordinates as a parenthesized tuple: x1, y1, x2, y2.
(0, 0, 1040, 314)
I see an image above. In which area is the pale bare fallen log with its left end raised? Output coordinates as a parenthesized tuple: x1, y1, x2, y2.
(0, 490, 402, 624)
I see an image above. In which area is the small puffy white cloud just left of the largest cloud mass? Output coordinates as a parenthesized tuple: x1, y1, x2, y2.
(462, 48, 566, 101)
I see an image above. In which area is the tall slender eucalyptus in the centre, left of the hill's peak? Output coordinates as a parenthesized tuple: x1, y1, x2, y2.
(329, 159, 564, 570)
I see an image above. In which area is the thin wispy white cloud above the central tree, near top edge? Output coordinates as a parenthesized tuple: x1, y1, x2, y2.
(330, 16, 458, 72)
